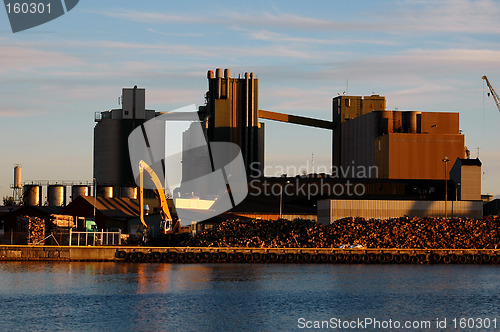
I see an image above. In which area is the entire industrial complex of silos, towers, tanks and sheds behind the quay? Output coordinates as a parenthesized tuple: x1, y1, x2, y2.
(1, 68, 490, 241)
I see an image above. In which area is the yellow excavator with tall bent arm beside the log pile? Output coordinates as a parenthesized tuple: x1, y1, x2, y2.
(139, 160, 180, 235)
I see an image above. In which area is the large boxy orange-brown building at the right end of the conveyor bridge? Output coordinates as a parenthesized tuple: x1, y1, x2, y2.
(332, 95, 466, 180)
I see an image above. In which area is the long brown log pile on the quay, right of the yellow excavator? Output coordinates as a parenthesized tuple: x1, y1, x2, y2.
(188, 217, 500, 249)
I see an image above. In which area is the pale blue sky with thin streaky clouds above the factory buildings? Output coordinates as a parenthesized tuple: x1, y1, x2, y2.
(0, 0, 500, 197)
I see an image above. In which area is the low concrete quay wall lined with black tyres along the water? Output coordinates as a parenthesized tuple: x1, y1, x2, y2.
(0, 246, 500, 264)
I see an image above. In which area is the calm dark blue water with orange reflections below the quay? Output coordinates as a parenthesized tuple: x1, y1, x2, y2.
(0, 262, 500, 331)
